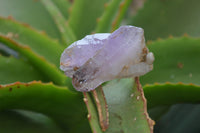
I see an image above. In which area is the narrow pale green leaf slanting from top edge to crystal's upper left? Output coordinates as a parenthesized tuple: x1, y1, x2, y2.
(42, 0, 76, 45)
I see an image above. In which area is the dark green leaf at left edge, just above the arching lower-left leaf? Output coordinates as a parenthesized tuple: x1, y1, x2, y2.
(0, 55, 47, 84)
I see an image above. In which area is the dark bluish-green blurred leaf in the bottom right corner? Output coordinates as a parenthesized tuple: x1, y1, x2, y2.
(155, 104, 200, 133)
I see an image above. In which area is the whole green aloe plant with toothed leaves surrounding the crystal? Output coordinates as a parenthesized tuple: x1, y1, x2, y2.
(0, 0, 200, 133)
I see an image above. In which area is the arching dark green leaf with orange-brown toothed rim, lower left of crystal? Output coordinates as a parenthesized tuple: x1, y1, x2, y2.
(0, 82, 89, 132)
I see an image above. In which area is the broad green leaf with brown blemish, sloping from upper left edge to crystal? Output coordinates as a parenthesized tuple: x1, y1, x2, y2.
(0, 17, 63, 67)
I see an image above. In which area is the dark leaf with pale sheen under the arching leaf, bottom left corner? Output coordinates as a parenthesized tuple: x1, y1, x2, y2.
(0, 110, 64, 133)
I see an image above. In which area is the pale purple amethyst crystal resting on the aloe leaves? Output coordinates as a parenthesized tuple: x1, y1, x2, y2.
(60, 26, 154, 91)
